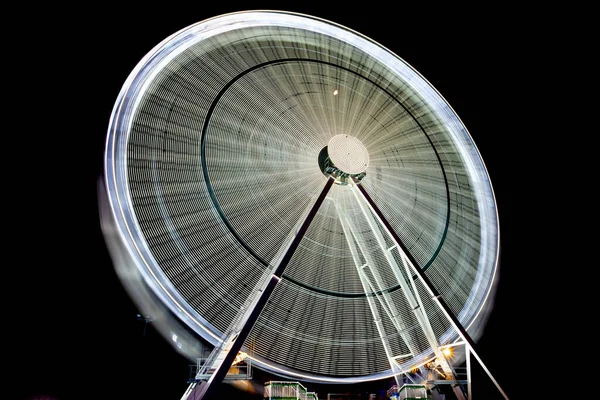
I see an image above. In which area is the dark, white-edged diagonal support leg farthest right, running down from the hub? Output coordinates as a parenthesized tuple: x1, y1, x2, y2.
(353, 181, 509, 400)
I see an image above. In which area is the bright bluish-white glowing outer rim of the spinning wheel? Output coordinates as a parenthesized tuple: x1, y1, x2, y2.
(105, 11, 499, 382)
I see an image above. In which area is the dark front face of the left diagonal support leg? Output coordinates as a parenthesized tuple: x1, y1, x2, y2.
(190, 177, 334, 400)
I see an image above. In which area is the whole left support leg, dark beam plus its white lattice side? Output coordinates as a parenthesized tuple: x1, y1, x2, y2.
(184, 177, 334, 400)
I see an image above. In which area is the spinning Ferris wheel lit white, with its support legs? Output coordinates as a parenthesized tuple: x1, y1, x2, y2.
(104, 11, 507, 398)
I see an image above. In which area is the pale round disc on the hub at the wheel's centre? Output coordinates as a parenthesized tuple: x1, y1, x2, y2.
(327, 134, 369, 175)
